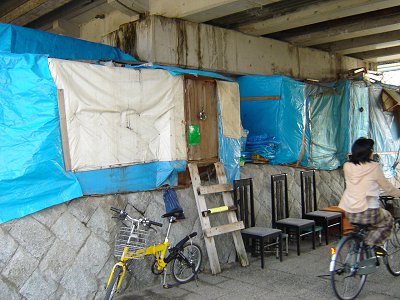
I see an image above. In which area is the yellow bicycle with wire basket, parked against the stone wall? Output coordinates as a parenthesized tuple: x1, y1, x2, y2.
(104, 207, 203, 300)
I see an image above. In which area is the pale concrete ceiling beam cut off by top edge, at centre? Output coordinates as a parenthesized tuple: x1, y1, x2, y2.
(150, 0, 282, 23)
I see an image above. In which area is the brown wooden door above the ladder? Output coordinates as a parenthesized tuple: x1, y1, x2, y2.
(185, 78, 218, 162)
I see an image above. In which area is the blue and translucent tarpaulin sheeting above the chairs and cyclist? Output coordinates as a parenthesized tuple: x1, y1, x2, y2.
(238, 76, 400, 172)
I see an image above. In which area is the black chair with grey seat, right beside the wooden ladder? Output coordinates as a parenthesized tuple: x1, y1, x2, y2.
(233, 178, 288, 268)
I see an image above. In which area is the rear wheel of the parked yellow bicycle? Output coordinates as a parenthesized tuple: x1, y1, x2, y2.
(172, 243, 203, 283)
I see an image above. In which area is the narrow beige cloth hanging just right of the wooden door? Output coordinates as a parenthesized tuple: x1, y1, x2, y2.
(217, 80, 242, 139)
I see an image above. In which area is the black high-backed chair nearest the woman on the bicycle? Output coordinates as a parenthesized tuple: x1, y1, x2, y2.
(300, 170, 343, 245)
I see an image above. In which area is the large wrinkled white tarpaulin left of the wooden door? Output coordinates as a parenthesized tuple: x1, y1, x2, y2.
(49, 59, 187, 171)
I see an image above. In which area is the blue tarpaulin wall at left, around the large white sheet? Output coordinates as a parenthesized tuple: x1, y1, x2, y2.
(0, 24, 195, 223)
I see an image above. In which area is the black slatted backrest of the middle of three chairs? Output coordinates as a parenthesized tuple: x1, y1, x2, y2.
(271, 173, 289, 227)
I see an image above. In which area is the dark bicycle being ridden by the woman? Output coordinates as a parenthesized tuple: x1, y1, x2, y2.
(329, 196, 400, 300)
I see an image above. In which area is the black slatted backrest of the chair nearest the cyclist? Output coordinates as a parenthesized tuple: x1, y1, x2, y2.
(300, 170, 318, 217)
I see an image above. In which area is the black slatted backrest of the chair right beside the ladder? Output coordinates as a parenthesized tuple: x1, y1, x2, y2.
(233, 178, 256, 228)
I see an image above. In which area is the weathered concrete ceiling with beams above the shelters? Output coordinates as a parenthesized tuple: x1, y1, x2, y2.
(0, 0, 400, 63)
